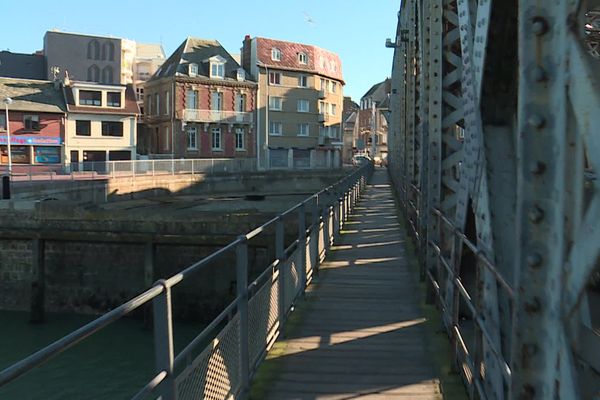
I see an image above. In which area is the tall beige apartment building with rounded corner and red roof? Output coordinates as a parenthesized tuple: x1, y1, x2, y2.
(241, 36, 344, 168)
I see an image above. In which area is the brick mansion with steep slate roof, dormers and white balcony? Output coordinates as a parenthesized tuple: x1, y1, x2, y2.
(142, 37, 257, 158)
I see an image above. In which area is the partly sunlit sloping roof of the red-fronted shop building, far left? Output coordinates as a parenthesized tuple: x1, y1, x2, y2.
(0, 78, 66, 113)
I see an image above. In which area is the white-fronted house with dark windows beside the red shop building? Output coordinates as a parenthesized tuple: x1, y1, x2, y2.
(64, 79, 139, 165)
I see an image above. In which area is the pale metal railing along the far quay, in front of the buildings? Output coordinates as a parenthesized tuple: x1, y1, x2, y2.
(0, 158, 256, 181)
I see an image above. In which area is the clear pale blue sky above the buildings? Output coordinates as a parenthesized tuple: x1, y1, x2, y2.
(0, 0, 400, 101)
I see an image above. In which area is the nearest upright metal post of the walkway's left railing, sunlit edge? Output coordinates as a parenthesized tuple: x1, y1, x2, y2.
(152, 279, 176, 400)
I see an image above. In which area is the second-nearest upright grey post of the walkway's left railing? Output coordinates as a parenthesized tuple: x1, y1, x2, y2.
(235, 235, 250, 399)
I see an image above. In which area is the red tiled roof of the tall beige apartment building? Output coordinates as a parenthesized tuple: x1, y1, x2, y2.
(253, 37, 344, 82)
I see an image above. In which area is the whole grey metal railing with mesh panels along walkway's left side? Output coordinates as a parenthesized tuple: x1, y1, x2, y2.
(0, 164, 373, 400)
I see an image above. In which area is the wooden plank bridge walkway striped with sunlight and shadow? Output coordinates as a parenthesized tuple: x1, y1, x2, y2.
(251, 169, 442, 400)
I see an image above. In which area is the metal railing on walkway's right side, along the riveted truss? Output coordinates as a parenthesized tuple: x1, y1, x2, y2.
(392, 175, 515, 398)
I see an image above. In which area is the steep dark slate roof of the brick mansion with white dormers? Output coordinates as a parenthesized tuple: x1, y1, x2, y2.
(150, 37, 254, 81)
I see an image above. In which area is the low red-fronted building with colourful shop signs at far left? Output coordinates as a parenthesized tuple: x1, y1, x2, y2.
(0, 78, 66, 169)
